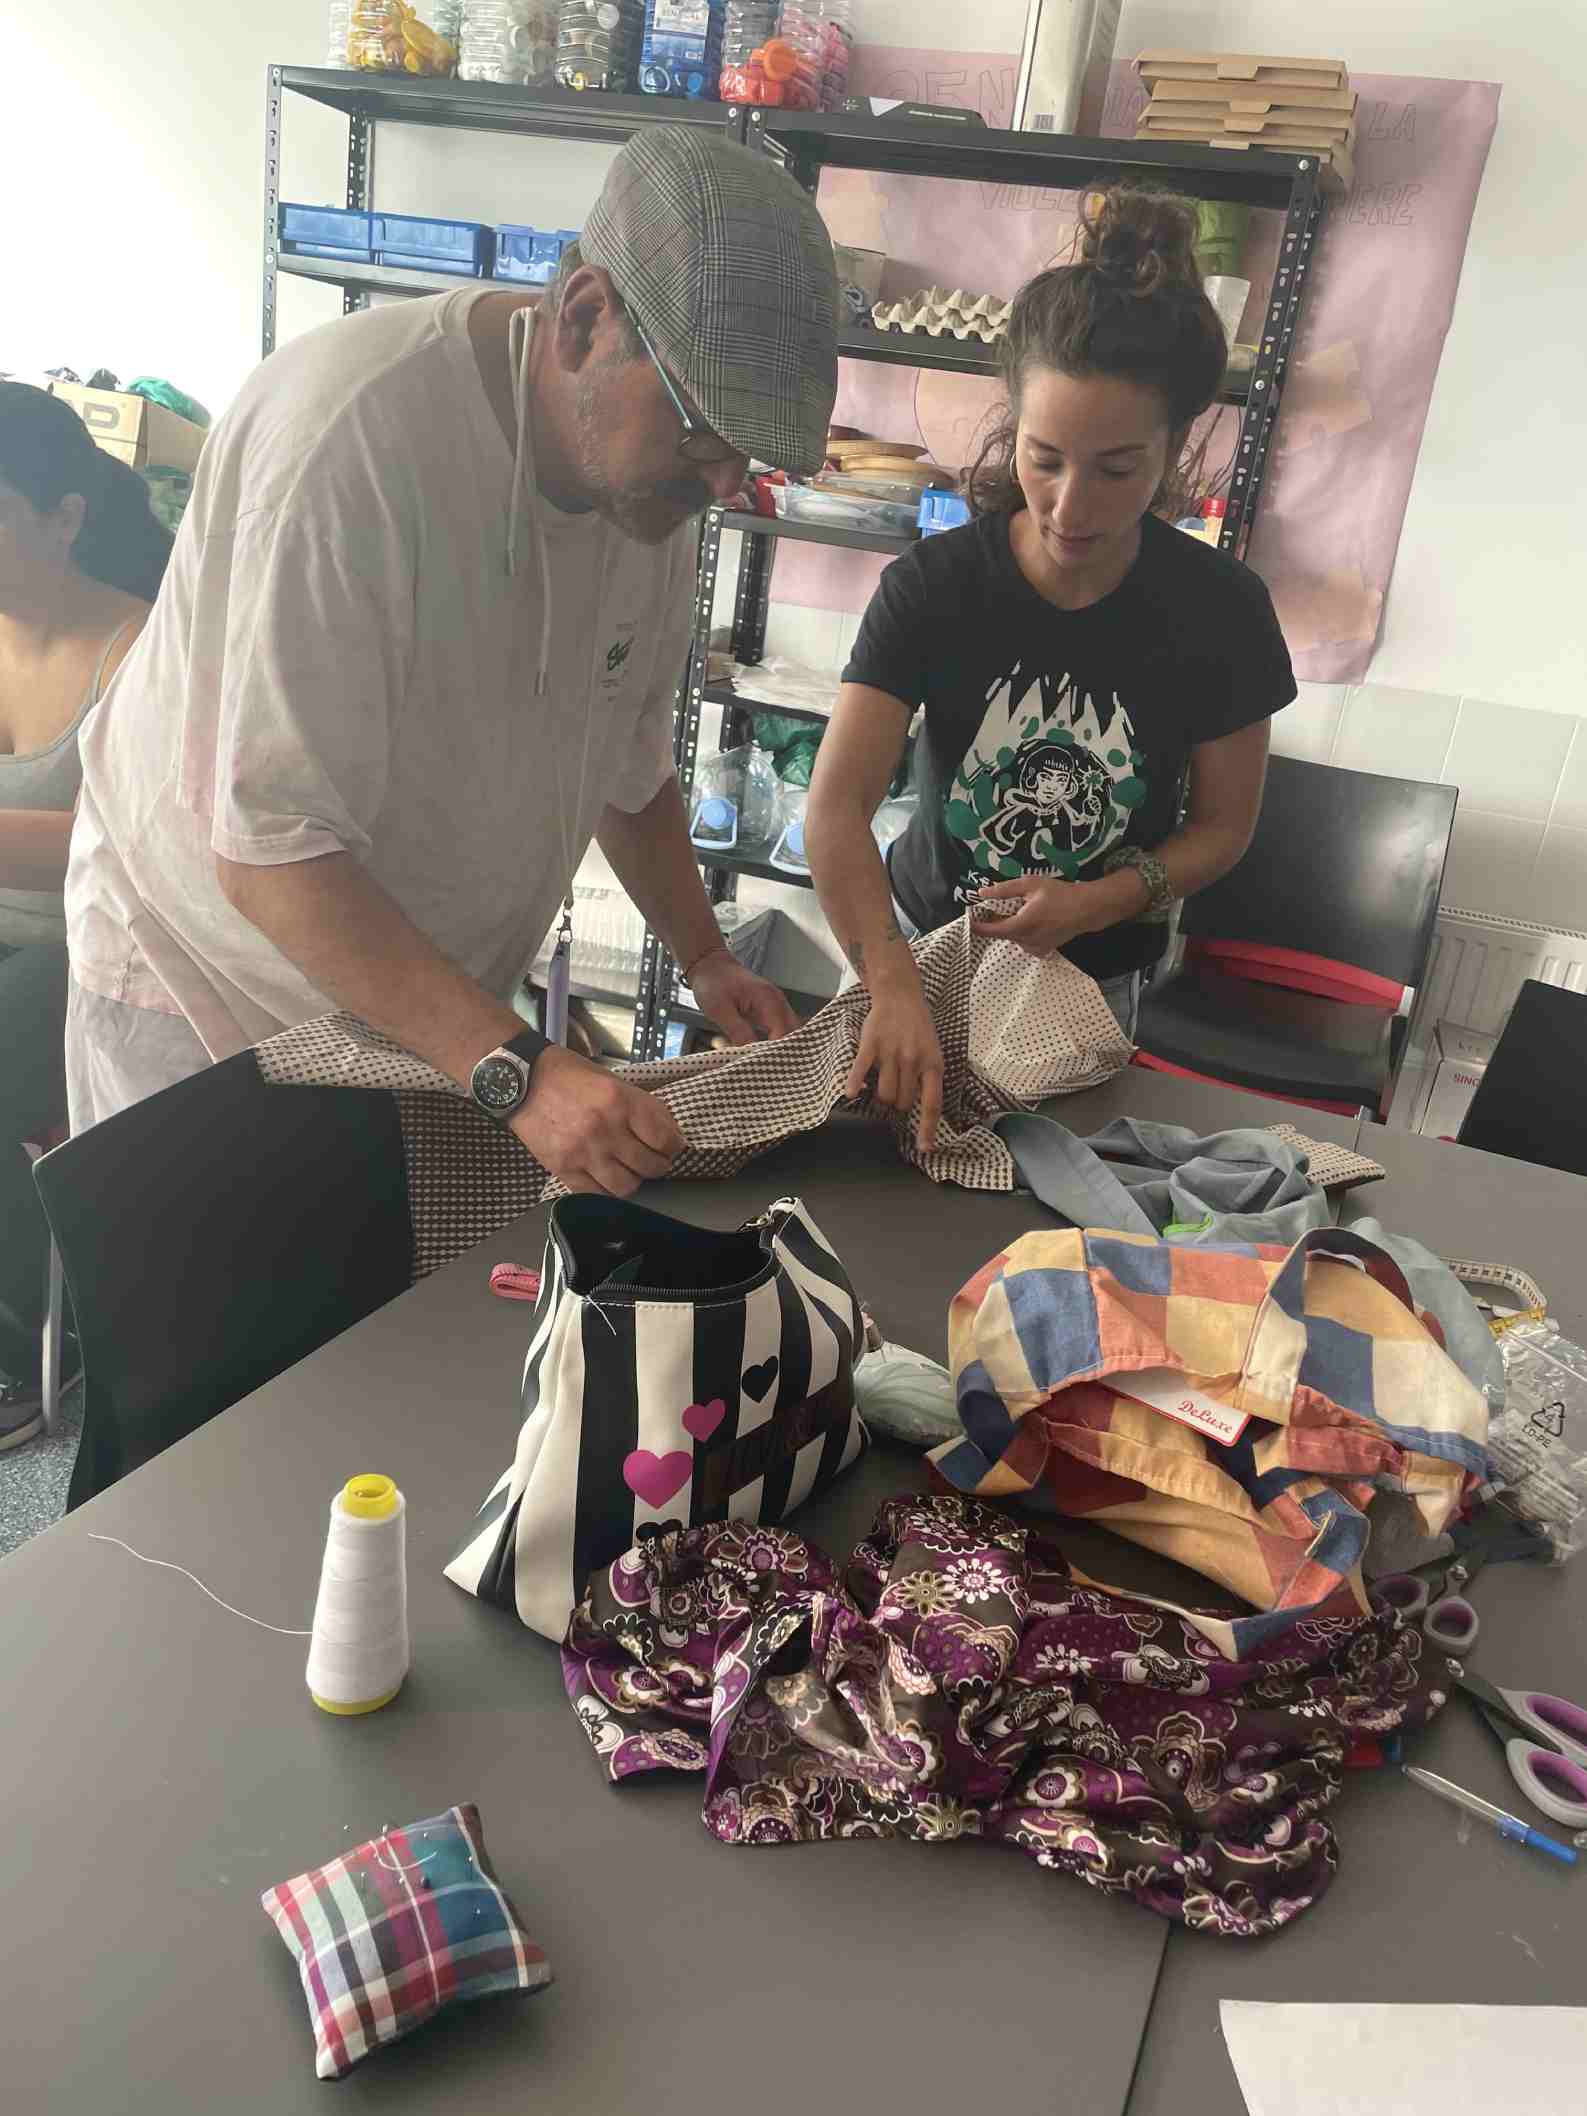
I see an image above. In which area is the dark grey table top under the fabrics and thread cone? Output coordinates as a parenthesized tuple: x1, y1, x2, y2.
(0, 1073, 1587, 2116)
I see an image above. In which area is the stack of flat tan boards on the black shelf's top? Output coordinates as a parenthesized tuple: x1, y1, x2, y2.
(1134, 51, 1356, 190)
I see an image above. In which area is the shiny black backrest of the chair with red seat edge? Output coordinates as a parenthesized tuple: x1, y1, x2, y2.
(1181, 758, 1456, 986)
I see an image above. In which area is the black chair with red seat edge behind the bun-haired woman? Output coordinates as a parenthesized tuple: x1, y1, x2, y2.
(1136, 758, 1456, 1113)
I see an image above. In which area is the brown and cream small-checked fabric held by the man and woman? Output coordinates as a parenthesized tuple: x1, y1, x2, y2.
(254, 918, 1130, 1278)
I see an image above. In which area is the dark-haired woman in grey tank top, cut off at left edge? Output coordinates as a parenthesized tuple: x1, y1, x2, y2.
(0, 383, 171, 1449)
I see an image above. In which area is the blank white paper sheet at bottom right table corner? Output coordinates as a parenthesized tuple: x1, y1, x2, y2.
(1219, 1998, 1587, 2116)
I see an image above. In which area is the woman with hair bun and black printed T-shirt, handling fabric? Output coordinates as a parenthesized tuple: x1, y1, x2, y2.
(806, 188, 1295, 1147)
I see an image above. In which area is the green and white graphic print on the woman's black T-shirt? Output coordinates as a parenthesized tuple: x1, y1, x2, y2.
(946, 667, 1149, 901)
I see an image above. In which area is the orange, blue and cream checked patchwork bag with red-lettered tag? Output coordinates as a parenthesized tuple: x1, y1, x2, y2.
(931, 1227, 1488, 1657)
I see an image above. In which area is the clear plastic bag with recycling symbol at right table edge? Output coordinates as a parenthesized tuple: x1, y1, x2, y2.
(1488, 1323, 1587, 1564)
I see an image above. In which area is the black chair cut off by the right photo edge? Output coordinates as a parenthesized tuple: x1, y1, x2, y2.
(1460, 978, 1587, 1176)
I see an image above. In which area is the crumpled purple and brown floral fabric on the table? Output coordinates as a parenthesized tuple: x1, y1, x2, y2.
(563, 1496, 1447, 1938)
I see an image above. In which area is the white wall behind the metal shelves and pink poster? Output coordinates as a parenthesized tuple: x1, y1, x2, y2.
(0, 0, 1587, 927)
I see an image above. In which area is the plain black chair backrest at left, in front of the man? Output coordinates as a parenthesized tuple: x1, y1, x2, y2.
(34, 1052, 413, 1507)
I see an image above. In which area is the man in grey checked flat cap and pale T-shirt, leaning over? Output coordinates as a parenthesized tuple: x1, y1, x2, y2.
(66, 125, 838, 1193)
